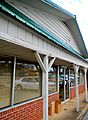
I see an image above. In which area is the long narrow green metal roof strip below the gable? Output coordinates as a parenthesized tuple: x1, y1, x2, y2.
(0, 1, 85, 60)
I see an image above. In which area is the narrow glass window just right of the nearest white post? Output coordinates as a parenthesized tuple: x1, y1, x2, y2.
(48, 67, 57, 93)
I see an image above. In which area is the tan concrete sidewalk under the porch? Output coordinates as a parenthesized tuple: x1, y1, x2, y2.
(49, 92, 88, 120)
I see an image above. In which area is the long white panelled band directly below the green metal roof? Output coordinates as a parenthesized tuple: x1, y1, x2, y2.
(0, 15, 88, 67)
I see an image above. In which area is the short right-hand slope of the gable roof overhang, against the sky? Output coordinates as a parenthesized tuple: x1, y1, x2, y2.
(67, 19, 88, 58)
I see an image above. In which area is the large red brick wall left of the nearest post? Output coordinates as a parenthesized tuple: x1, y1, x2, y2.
(0, 99, 43, 120)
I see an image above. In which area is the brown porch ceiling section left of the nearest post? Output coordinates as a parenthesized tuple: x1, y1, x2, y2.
(0, 40, 37, 62)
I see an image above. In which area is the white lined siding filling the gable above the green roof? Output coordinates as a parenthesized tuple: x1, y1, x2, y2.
(6, 2, 81, 54)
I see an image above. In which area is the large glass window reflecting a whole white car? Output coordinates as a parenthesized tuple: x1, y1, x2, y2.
(14, 62, 41, 103)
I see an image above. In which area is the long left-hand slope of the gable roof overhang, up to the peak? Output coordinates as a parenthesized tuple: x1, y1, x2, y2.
(5, 0, 75, 20)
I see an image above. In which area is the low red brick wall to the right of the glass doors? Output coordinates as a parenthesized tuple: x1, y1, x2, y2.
(70, 84, 85, 99)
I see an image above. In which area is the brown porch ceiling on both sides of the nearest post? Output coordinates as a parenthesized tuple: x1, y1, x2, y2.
(0, 40, 72, 67)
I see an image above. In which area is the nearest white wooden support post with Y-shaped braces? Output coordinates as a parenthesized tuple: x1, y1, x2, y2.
(35, 52, 55, 120)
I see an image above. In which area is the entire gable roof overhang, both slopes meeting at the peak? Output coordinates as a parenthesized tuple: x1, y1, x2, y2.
(5, 0, 88, 58)
